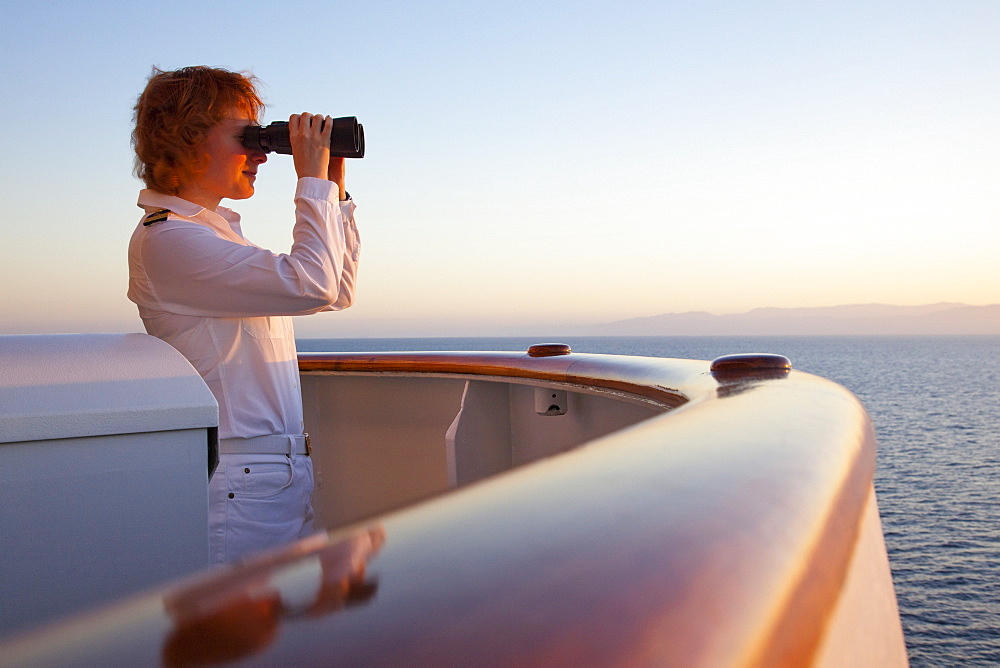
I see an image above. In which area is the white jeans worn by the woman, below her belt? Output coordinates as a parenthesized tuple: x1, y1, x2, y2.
(208, 455, 313, 566)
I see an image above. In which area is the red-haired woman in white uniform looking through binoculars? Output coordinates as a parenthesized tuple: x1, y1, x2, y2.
(128, 67, 360, 564)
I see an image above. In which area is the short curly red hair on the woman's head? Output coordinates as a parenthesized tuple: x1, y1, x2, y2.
(132, 66, 264, 195)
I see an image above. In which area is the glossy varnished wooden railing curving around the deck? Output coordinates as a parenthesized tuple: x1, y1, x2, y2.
(0, 348, 905, 666)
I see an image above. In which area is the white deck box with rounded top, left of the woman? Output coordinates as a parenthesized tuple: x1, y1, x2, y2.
(0, 334, 218, 636)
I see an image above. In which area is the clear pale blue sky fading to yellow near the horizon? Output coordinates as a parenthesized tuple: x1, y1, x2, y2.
(0, 0, 1000, 337)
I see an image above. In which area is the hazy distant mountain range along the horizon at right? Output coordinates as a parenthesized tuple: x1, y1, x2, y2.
(587, 303, 1000, 336)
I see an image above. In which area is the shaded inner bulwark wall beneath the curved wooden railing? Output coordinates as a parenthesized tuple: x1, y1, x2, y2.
(302, 373, 662, 529)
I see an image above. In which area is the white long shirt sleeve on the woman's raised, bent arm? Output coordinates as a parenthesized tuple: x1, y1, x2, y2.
(141, 178, 360, 318)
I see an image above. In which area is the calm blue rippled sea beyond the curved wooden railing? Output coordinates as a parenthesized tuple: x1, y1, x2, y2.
(299, 337, 1000, 666)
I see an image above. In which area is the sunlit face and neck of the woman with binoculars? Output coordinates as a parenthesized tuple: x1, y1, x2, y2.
(178, 110, 267, 211)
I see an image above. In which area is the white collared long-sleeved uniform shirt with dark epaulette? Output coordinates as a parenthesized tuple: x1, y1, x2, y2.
(128, 178, 360, 438)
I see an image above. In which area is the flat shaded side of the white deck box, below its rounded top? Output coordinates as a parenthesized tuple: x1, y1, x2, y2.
(0, 429, 208, 635)
